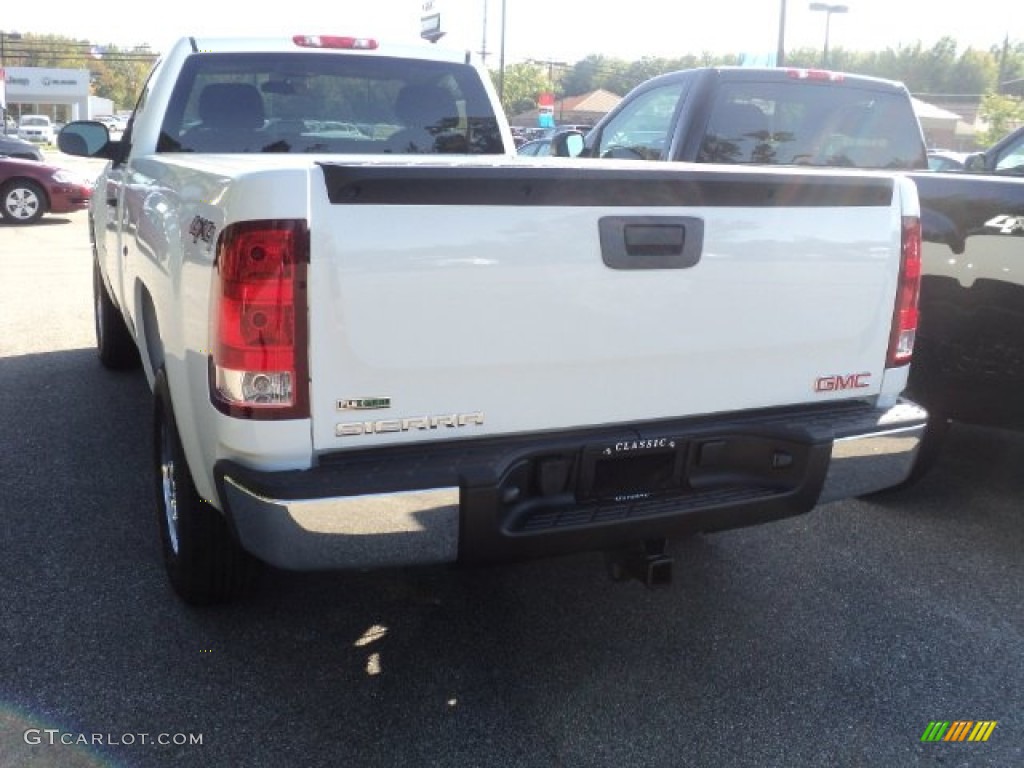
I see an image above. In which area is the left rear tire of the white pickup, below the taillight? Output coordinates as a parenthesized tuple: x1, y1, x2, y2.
(154, 369, 260, 605)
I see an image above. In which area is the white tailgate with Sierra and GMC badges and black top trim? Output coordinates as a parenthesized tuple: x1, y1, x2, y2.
(308, 161, 901, 452)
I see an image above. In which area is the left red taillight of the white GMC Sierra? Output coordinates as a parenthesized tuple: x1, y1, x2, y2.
(210, 220, 309, 419)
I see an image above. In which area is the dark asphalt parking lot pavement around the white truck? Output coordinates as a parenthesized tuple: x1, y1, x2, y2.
(0, 182, 1024, 768)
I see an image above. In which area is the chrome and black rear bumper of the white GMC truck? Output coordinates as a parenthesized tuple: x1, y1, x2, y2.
(217, 401, 927, 570)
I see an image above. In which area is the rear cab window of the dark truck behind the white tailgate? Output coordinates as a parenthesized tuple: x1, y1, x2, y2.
(697, 79, 928, 170)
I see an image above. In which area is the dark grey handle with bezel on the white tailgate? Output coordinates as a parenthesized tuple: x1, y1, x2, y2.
(597, 216, 703, 269)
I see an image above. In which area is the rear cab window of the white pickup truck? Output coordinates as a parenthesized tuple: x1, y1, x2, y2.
(157, 51, 504, 155)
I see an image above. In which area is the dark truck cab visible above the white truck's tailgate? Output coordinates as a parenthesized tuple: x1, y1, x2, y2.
(552, 67, 928, 170)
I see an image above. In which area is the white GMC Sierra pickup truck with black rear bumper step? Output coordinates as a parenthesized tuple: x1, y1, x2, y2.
(58, 36, 927, 603)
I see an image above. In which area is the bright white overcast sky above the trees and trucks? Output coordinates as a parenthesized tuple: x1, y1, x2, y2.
(0, 0, 1024, 67)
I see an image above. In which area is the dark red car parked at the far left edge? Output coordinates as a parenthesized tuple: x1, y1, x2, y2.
(0, 157, 92, 224)
